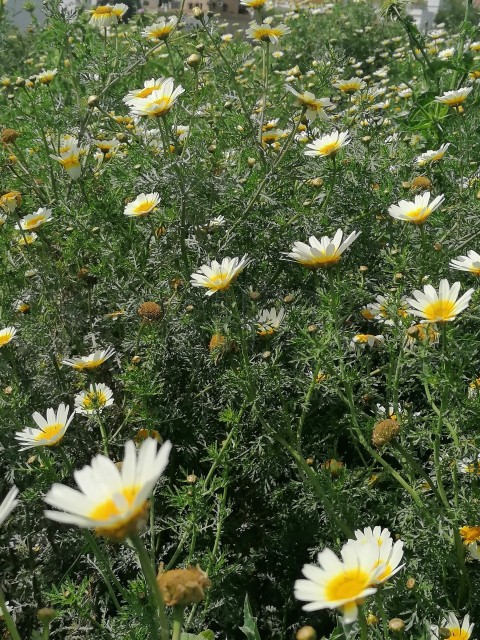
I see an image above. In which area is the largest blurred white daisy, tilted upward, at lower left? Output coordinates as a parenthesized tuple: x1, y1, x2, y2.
(45, 438, 172, 540)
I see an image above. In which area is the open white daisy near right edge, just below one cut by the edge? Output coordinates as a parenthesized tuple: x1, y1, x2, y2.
(407, 279, 473, 322)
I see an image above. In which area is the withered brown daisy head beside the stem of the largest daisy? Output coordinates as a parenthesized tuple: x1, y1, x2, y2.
(157, 565, 212, 607)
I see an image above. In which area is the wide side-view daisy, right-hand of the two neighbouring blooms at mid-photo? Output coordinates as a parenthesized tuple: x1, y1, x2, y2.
(286, 229, 361, 269)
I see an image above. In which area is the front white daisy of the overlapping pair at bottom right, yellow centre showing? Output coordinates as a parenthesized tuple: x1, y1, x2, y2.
(295, 543, 385, 624)
